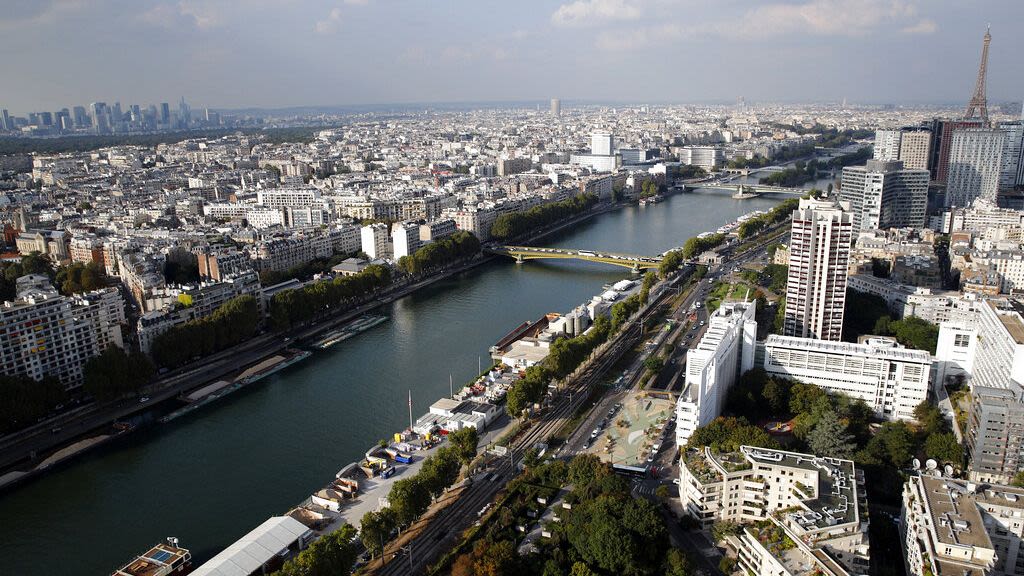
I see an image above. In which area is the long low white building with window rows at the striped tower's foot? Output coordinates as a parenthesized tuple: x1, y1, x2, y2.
(763, 334, 932, 420)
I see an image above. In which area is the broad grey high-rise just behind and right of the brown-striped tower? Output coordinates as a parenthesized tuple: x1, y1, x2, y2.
(839, 160, 930, 232)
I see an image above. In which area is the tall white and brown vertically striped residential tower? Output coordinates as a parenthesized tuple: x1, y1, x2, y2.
(783, 199, 853, 340)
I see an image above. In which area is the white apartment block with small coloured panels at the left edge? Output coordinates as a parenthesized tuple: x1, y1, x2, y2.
(0, 278, 125, 388)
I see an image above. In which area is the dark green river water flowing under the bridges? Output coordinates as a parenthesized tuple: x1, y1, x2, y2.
(0, 191, 777, 576)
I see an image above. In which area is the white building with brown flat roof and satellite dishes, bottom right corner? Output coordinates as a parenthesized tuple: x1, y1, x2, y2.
(900, 474, 1024, 576)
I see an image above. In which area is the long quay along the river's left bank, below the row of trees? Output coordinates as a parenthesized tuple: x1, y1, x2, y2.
(0, 204, 628, 492)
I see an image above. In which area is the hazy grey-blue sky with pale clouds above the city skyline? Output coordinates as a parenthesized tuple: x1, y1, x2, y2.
(0, 0, 1024, 115)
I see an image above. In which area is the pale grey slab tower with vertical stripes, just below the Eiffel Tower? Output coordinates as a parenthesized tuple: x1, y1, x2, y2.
(946, 128, 1006, 206)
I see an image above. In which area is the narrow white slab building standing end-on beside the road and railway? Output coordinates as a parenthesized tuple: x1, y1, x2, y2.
(676, 302, 758, 446)
